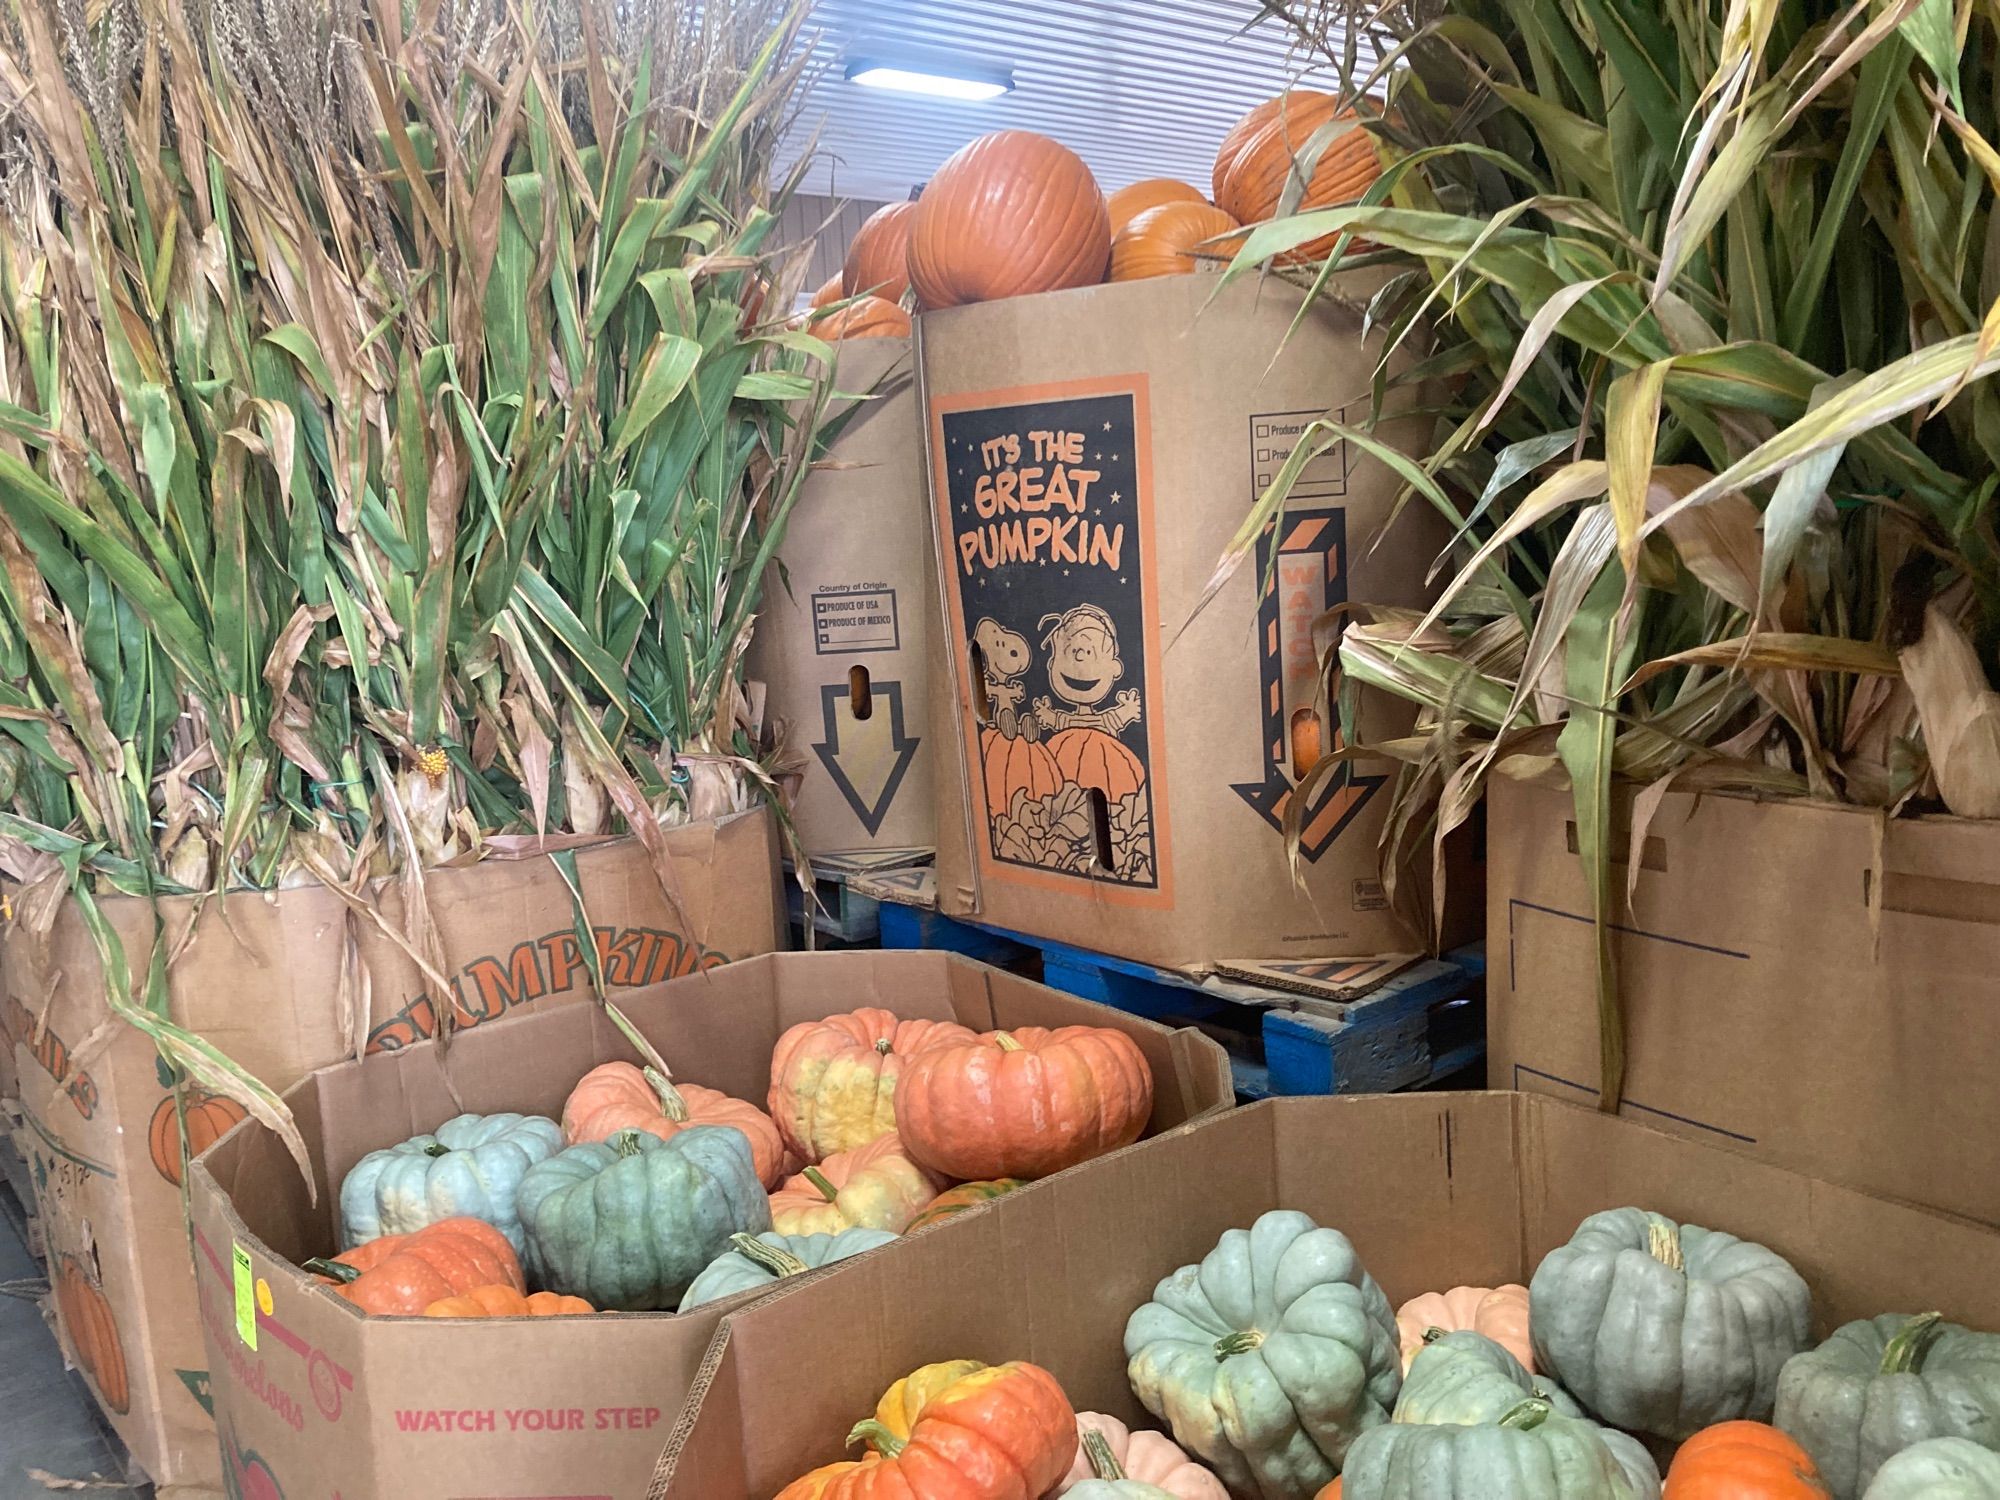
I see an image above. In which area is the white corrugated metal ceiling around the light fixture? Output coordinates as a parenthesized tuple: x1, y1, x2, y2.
(786, 0, 1344, 202)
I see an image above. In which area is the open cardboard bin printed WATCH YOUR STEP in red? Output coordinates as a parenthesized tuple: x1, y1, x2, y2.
(192, 952, 1234, 1500)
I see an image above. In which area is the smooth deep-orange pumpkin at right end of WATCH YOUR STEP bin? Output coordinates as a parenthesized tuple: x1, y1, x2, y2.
(896, 1026, 1152, 1180)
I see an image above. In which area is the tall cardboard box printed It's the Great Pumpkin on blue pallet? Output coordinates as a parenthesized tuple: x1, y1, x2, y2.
(918, 276, 1446, 970)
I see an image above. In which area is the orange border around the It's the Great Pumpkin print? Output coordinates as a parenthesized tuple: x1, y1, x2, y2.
(926, 372, 1174, 910)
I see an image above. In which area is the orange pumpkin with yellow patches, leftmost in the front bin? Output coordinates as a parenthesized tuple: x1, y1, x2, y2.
(778, 1364, 1076, 1500)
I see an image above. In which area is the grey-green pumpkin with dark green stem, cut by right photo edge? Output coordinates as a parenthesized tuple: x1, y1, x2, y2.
(1776, 1312, 2000, 1500)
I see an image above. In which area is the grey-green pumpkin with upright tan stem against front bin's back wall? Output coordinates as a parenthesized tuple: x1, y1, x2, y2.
(1528, 1208, 1812, 1440)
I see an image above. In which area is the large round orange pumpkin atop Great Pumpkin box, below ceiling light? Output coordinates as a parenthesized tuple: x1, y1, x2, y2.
(910, 130, 1112, 308)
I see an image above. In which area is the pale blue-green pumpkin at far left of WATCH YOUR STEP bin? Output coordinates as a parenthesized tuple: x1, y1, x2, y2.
(340, 1114, 562, 1254)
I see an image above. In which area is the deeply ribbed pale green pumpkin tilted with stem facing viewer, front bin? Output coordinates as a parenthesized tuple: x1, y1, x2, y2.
(1124, 1210, 1402, 1500)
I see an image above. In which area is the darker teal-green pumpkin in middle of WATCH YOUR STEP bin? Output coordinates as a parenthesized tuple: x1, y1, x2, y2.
(520, 1126, 770, 1312)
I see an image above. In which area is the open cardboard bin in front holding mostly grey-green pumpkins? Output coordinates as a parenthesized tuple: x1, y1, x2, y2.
(650, 1094, 2000, 1500)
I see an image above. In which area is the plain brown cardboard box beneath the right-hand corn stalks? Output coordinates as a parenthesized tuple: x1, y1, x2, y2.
(1486, 780, 2000, 1224)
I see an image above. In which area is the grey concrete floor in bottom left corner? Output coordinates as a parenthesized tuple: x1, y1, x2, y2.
(0, 1168, 152, 1500)
